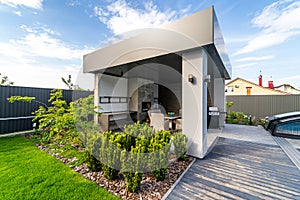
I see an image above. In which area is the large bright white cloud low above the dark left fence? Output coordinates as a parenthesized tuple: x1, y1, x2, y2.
(0, 25, 90, 88)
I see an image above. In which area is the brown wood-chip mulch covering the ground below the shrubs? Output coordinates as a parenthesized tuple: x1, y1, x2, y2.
(38, 142, 193, 200)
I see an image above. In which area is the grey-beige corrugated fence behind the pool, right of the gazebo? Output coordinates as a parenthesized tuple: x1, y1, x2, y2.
(226, 95, 300, 118)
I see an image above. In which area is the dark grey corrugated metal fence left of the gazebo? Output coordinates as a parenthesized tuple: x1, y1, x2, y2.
(0, 86, 93, 134)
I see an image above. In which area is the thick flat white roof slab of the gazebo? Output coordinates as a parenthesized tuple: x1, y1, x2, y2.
(83, 7, 231, 79)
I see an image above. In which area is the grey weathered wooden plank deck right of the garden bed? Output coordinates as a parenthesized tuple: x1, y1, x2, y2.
(166, 138, 300, 200)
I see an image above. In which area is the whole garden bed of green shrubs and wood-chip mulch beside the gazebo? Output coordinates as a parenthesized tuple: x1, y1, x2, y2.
(12, 89, 192, 199)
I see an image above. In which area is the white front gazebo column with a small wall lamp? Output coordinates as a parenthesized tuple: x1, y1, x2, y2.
(182, 49, 207, 158)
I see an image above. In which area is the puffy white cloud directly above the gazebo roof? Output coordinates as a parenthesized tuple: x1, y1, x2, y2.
(94, 0, 190, 35)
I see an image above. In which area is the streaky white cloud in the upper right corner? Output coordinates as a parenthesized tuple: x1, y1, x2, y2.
(235, 0, 300, 55)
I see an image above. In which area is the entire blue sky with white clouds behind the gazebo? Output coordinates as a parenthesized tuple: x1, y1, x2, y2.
(0, 0, 300, 88)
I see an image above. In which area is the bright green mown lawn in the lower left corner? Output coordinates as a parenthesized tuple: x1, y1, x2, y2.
(0, 136, 118, 200)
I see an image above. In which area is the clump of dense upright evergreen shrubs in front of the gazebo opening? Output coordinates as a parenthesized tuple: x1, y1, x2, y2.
(86, 122, 186, 192)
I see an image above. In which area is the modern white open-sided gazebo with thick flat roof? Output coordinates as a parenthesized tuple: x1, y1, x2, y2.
(83, 7, 231, 158)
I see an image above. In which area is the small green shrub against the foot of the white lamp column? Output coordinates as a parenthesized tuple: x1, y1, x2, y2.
(172, 132, 187, 160)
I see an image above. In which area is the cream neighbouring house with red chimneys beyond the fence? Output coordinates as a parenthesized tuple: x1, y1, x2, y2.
(225, 76, 288, 96)
